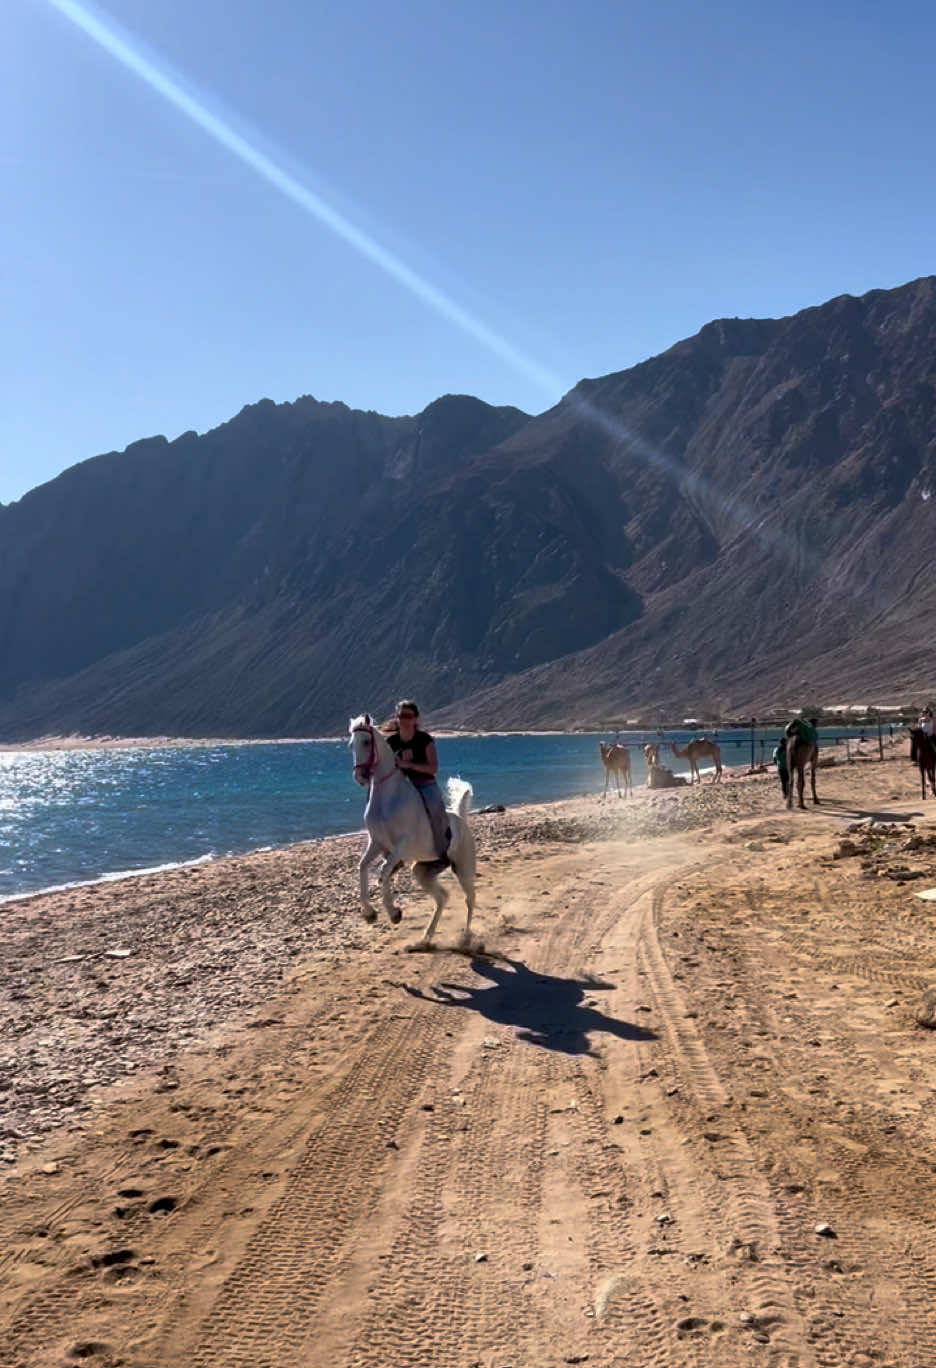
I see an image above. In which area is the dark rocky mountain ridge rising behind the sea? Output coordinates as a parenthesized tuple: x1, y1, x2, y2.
(0, 278, 936, 739)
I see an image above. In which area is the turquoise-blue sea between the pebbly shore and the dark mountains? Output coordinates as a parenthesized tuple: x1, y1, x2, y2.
(0, 731, 870, 900)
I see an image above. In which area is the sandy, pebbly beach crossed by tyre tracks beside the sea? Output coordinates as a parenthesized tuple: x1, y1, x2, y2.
(0, 747, 936, 1368)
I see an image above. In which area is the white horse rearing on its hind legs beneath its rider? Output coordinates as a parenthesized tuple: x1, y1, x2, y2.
(348, 713, 475, 949)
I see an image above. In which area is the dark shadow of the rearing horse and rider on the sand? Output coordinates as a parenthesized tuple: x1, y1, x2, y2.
(398, 958, 657, 1055)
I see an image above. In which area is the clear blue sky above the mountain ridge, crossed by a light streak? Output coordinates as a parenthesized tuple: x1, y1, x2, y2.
(0, 0, 936, 502)
